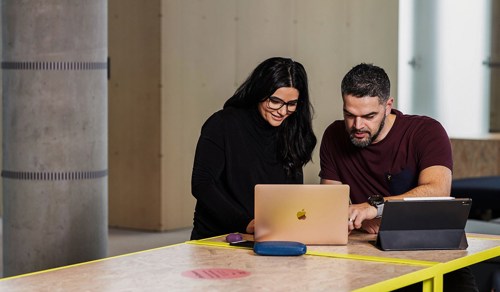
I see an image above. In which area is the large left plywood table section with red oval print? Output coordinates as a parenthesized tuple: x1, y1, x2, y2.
(0, 244, 422, 291)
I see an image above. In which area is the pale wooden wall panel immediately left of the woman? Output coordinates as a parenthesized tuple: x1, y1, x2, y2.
(161, 0, 237, 229)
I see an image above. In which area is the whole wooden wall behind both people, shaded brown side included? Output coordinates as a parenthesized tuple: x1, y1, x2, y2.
(109, 0, 398, 230)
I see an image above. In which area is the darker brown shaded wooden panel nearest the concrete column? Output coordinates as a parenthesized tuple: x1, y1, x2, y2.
(108, 0, 161, 230)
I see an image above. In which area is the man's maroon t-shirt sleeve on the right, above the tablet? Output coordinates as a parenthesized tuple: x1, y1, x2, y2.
(415, 118, 453, 171)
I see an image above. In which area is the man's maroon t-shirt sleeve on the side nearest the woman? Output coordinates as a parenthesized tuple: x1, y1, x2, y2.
(319, 124, 340, 181)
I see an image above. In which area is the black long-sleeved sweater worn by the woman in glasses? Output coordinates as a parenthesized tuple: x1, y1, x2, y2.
(191, 107, 303, 239)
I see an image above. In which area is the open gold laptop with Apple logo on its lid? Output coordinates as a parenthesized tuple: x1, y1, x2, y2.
(254, 184, 349, 245)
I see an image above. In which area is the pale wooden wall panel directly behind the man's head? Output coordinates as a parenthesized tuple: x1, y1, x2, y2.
(291, 0, 399, 183)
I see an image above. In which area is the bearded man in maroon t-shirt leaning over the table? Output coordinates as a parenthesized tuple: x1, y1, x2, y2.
(319, 64, 477, 291)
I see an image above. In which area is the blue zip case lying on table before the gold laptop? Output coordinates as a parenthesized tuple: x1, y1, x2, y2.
(253, 241, 307, 256)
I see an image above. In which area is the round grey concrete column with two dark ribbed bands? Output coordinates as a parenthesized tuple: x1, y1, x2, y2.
(1, 0, 108, 276)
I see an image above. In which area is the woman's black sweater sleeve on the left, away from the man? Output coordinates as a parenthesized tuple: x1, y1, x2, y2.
(191, 112, 252, 232)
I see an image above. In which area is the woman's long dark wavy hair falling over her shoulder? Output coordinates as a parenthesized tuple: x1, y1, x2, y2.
(224, 57, 316, 176)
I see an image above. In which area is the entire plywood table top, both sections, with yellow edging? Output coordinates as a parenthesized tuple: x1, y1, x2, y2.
(0, 234, 500, 291)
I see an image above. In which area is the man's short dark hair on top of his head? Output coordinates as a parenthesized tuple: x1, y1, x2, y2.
(341, 63, 391, 104)
